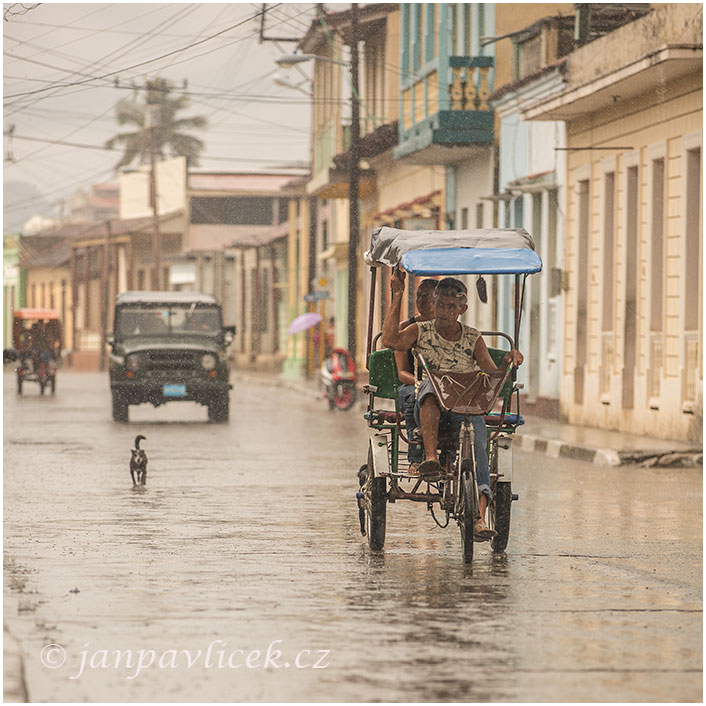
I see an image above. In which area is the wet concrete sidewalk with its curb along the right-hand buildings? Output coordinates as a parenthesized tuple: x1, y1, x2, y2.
(232, 370, 703, 467)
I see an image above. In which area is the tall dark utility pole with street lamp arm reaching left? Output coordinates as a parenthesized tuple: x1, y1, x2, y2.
(276, 3, 360, 359)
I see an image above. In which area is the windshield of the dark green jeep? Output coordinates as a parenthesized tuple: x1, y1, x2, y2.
(115, 302, 223, 339)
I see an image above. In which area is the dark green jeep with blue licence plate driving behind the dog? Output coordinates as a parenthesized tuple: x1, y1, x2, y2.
(106, 292, 235, 422)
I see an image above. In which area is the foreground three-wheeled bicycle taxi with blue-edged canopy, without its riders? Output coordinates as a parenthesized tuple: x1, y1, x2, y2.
(357, 227, 542, 563)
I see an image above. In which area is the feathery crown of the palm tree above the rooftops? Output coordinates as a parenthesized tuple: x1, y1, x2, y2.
(105, 78, 208, 171)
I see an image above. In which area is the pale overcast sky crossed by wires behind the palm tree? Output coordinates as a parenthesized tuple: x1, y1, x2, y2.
(3, 2, 328, 233)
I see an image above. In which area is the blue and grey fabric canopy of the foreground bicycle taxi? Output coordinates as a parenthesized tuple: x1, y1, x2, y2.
(365, 226, 542, 276)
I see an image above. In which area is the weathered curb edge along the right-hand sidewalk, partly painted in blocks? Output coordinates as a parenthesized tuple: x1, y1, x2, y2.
(233, 372, 703, 468)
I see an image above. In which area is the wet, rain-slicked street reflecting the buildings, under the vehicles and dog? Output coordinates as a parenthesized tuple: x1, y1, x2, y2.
(4, 371, 702, 702)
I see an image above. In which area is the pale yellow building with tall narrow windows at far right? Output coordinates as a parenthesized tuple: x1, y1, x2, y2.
(523, 4, 703, 440)
